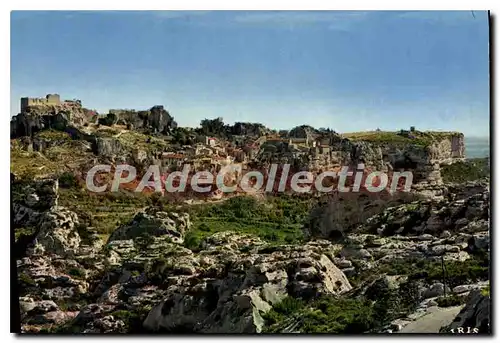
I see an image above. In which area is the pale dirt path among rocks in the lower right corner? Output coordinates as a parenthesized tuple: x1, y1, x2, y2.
(399, 306, 463, 333)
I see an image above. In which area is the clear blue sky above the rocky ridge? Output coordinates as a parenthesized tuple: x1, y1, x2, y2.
(11, 11, 489, 136)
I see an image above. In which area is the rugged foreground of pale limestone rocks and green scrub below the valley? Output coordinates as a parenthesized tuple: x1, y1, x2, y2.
(13, 175, 490, 333)
